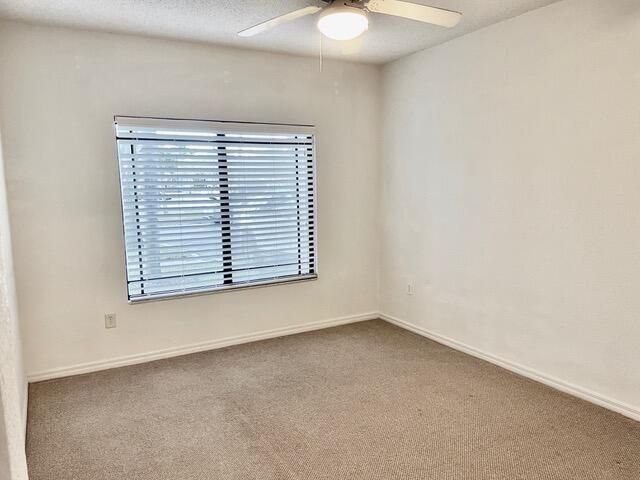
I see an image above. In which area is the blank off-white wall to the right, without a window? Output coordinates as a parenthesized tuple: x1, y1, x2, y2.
(380, 0, 640, 412)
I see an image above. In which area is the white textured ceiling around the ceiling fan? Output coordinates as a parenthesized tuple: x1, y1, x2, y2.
(0, 0, 556, 63)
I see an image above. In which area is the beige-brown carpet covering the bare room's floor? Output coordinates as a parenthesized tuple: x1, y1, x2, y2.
(27, 321, 640, 480)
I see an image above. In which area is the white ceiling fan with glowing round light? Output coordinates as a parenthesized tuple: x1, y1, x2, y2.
(238, 0, 462, 40)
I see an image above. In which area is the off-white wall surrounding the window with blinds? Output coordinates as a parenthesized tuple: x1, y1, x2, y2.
(0, 22, 379, 374)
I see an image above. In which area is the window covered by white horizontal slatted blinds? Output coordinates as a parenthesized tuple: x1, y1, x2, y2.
(115, 117, 317, 302)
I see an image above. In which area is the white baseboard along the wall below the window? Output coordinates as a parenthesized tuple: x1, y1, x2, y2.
(27, 312, 379, 383)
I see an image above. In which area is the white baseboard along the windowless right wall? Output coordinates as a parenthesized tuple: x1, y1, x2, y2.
(378, 313, 640, 421)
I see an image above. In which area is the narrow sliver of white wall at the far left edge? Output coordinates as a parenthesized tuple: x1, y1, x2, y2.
(0, 131, 27, 480)
